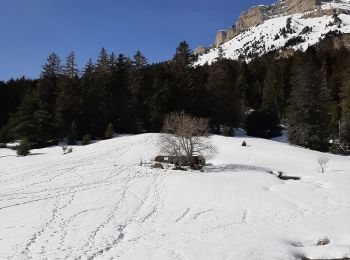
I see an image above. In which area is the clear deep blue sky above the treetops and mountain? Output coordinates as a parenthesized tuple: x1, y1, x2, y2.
(0, 0, 274, 80)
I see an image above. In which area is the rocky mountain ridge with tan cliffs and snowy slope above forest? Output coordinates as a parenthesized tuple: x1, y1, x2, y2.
(195, 0, 350, 65)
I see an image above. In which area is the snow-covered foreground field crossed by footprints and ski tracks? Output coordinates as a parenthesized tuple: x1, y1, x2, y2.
(0, 134, 350, 260)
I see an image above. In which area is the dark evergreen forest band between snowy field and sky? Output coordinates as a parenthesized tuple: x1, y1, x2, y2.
(0, 39, 350, 154)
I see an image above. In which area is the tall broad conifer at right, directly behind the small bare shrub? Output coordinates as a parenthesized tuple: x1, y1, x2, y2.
(288, 50, 329, 151)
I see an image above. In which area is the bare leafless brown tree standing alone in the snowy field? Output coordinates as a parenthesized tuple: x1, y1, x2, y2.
(160, 112, 215, 168)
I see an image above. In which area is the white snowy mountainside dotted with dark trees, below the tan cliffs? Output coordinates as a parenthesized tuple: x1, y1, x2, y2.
(196, 12, 350, 65)
